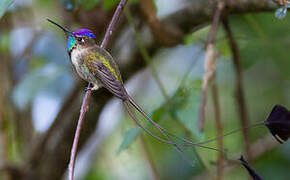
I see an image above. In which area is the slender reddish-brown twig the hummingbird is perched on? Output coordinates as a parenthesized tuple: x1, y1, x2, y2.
(68, 0, 127, 180)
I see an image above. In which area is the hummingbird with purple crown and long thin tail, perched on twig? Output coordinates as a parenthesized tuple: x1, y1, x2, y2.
(47, 19, 220, 162)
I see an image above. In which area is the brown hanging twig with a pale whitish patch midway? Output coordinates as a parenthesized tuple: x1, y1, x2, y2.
(199, 1, 224, 130)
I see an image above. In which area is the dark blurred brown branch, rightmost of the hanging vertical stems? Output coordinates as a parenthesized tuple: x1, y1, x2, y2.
(223, 18, 251, 160)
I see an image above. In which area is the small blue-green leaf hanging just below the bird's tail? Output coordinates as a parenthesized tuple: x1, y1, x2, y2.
(117, 127, 141, 154)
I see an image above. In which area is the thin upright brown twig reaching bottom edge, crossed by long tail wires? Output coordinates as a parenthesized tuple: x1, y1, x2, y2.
(212, 75, 224, 180)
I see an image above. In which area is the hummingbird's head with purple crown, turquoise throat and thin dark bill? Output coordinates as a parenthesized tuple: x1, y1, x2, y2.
(47, 19, 96, 52)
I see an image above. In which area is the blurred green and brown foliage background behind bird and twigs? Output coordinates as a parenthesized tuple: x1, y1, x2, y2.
(0, 0, 290, 180)
